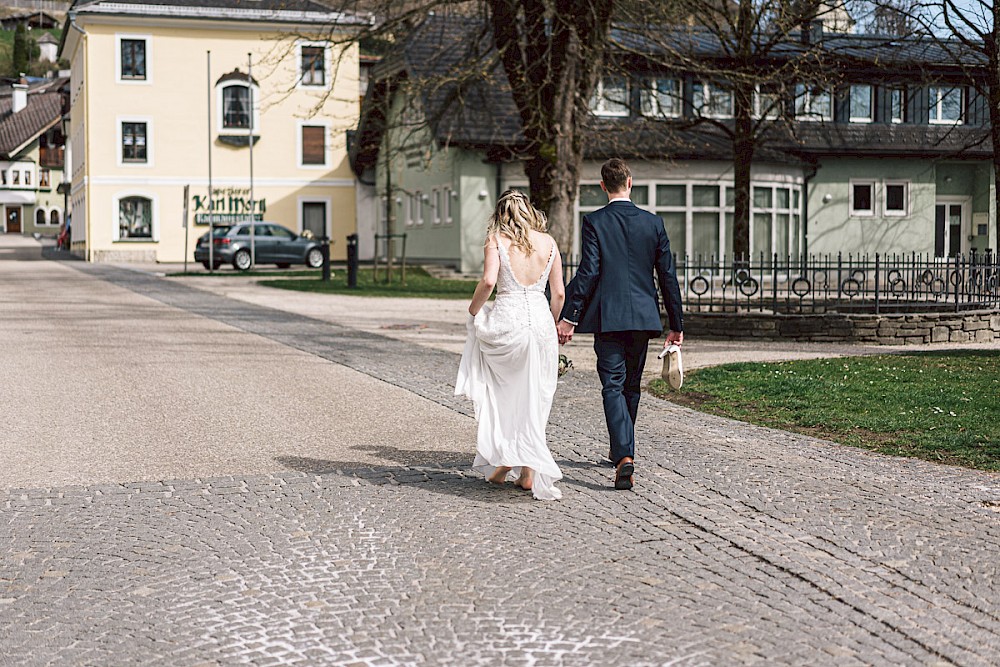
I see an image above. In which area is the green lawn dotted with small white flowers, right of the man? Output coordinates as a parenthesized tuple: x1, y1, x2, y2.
(651, 350, 1000, 470)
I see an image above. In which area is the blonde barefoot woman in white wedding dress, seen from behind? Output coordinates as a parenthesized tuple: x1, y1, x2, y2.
(455, 190, 565, 500)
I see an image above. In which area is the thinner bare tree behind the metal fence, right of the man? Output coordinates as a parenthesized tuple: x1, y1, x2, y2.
(635, 0, 839, 258)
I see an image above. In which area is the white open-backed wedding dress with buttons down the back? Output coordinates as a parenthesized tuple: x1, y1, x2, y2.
(455, 243, 562, 500)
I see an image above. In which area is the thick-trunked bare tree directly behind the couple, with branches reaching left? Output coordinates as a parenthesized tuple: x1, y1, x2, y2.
(325, 0, 616, 250)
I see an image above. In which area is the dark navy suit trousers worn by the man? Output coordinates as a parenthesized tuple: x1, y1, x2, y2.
(594, 331, 651, 464)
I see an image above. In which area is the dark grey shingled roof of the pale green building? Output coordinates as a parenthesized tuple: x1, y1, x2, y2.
(351, 16, 991, 174)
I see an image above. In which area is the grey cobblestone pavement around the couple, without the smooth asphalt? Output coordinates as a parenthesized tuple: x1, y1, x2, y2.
(0, 249, 1000, 667)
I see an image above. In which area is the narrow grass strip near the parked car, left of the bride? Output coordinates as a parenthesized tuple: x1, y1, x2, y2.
(260, 268, 476, 299)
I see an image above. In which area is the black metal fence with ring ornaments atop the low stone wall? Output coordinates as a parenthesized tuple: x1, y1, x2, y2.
(563, 252, 1000, 313)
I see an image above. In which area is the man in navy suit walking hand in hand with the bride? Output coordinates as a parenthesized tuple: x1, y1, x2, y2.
(557, 158, 684, 490)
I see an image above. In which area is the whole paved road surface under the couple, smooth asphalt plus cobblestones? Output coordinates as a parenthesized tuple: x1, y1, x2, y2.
(0, 241, 1000, 667)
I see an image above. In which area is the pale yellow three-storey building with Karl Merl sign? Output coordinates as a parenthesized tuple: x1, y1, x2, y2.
(60, 0, 366, 262)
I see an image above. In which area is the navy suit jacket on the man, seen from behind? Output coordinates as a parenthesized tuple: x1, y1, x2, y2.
(561, 201, 684, 336)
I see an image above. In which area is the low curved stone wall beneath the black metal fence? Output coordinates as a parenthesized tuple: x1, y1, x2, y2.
(684, 310, 1000, 345)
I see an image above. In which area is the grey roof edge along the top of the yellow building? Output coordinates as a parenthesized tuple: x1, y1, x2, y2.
(70, 0, 368, 25)
